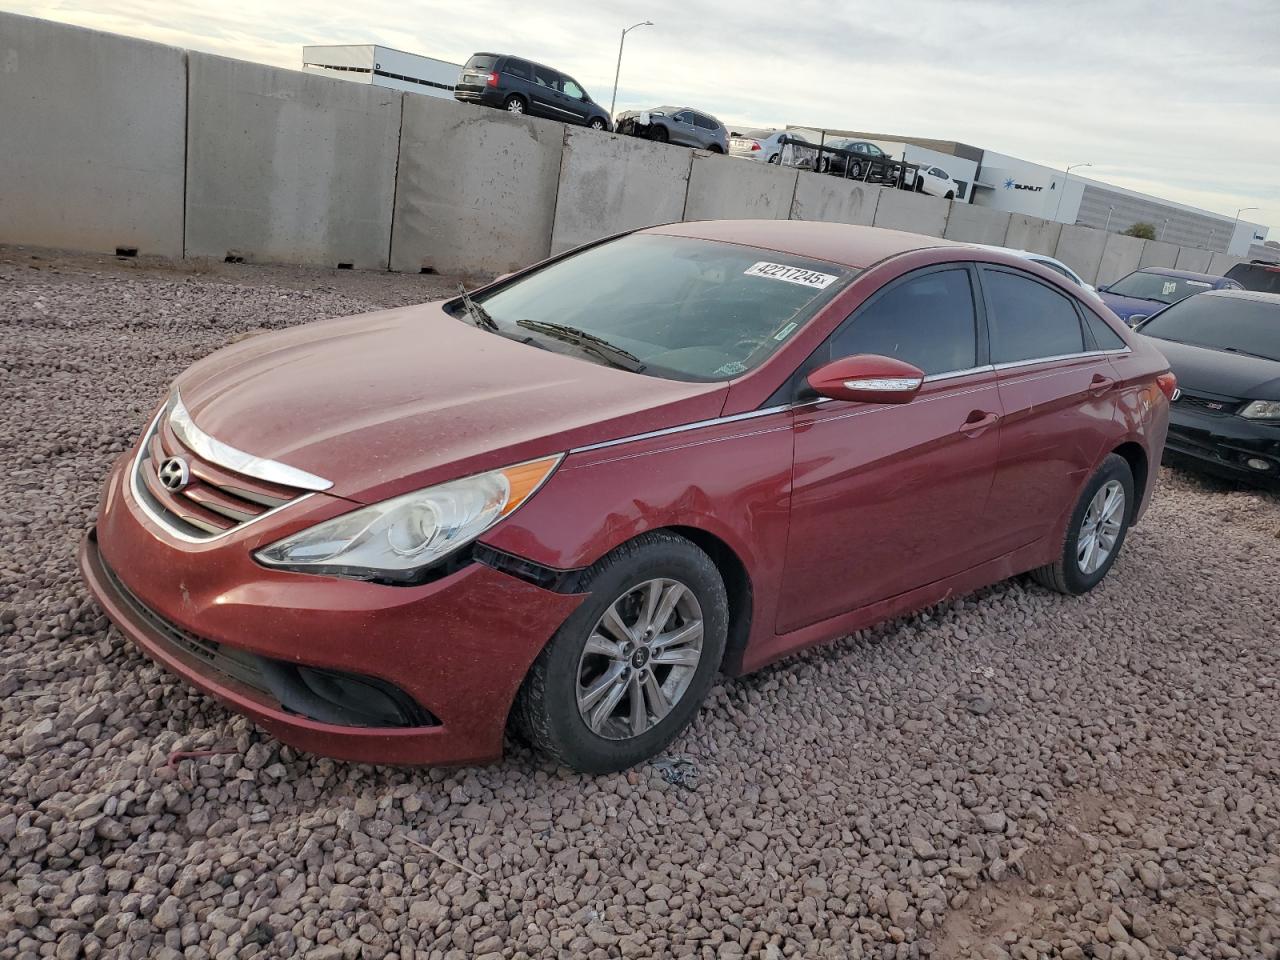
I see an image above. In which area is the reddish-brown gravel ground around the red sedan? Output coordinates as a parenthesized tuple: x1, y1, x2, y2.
(0, 247, 1280, 960)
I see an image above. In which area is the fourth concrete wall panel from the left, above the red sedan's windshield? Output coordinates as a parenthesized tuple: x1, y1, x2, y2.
(552, 133, 694, 253)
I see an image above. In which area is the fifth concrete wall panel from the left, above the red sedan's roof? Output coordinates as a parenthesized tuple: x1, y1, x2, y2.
(684, 151, 799, 220)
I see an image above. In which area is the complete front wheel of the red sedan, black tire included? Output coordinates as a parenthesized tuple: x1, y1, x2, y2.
(512, 532, 728, 773)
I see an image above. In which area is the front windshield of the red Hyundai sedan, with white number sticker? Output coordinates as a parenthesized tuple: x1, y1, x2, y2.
(475, 233, 854, 380)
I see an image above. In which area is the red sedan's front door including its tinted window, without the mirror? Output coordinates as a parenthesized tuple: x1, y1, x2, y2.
(777, 265, 1002, 634)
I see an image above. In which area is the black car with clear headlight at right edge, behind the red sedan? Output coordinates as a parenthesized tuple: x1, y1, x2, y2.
(1138, 291, 1280, 489)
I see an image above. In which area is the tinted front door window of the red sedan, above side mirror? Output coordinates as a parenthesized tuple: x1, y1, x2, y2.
(831, 269, 978, 374)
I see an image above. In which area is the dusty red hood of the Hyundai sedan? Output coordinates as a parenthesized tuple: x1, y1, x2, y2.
(177, 303, 727, 503)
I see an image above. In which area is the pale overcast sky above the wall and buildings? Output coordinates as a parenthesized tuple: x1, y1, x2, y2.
(0, 0, 1280, 238)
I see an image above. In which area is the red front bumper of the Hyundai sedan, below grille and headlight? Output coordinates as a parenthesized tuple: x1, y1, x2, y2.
(79, 457, 582, 764)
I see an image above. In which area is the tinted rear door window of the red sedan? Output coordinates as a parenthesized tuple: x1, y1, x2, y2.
(982, 269, 1084, 364)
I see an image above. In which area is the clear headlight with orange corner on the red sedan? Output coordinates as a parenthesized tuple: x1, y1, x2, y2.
(253, 454, 563, 582)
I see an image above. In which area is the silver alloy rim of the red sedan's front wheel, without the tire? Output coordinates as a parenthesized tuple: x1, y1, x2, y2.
(577, 579, 703, 740)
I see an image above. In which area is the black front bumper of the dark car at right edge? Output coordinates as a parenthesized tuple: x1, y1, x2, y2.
(1165, 404, 1280, 488)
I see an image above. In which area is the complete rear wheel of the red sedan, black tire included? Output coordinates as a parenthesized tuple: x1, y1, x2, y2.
(1030, 453, 1137, 595)
